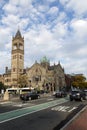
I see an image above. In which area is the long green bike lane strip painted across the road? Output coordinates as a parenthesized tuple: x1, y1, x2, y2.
(0, 98, 68, 123)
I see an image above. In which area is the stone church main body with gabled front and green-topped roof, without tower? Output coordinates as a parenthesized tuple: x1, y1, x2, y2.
(26, 57, 66, 91)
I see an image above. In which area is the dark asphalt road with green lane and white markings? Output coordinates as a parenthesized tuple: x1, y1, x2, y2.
(0, 97, 86, 130)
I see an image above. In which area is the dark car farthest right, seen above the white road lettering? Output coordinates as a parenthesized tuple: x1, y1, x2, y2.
(69, 90, 84, 101)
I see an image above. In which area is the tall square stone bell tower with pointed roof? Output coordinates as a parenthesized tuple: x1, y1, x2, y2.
(11, 29, 24, 87)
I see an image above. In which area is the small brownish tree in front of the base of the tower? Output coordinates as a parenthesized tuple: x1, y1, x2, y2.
(18, 75, 28, 88)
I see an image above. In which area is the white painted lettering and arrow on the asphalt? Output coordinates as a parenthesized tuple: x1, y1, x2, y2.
(51, 106, 77, 112)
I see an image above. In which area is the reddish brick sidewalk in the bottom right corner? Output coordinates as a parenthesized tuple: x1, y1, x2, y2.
(62, 106, 87, 130)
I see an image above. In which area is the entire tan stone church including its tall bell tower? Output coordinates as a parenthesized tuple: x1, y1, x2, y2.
(0, 29, 66, 91)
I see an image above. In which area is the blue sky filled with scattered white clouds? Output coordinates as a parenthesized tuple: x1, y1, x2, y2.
(0, 0, 87, 78)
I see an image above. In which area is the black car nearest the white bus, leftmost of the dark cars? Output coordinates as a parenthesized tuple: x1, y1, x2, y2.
(20, 92, 40, 101)
